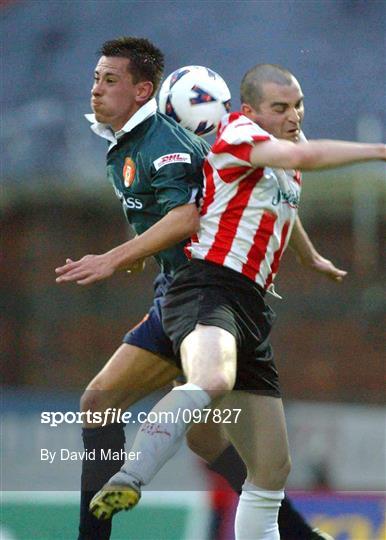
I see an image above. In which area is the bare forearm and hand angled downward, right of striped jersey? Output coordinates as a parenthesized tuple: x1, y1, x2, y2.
(289, 216, 347, 282)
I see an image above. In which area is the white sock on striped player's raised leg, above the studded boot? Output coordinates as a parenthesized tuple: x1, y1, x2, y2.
(111, 383, 211, 485)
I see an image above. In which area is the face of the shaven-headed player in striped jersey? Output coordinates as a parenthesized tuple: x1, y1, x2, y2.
(247, 79, 304, 142)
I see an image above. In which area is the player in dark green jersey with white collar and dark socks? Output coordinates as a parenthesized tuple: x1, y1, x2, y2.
(57, 38, 345, 540)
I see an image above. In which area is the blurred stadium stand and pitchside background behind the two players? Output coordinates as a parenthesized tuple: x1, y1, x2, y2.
(0, 0, 386, 540)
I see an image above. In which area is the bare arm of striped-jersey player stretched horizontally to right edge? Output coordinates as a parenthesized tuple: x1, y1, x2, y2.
(250, 140, 386, 171)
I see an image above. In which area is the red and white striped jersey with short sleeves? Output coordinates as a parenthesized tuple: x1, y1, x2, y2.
(187, 113, 301, 289)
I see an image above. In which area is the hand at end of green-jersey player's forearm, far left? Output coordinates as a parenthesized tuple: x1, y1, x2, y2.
(55, 254, 115, 285)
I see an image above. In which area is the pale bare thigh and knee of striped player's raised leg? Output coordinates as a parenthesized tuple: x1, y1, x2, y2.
(180, 324, 237, 395)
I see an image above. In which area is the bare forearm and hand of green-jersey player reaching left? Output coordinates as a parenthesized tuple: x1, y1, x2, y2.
(55, 204, 199, 285)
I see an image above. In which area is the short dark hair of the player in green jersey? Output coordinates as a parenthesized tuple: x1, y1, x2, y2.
(98, 36, 164, 96)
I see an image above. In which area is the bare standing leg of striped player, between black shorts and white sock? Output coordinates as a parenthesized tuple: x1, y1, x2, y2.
(221, 392, 290, 490)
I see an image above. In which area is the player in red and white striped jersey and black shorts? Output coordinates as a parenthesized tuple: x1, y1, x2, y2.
(91, 65, 386, 540)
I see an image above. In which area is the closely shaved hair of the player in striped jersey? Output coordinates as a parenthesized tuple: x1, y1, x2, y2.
(240, 64, 296, 109)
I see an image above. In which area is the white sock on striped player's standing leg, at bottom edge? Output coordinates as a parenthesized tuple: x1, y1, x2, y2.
(235, 482, 284, 540)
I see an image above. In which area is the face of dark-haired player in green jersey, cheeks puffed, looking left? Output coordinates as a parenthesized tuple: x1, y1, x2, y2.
(91, 56, 143, 131)
